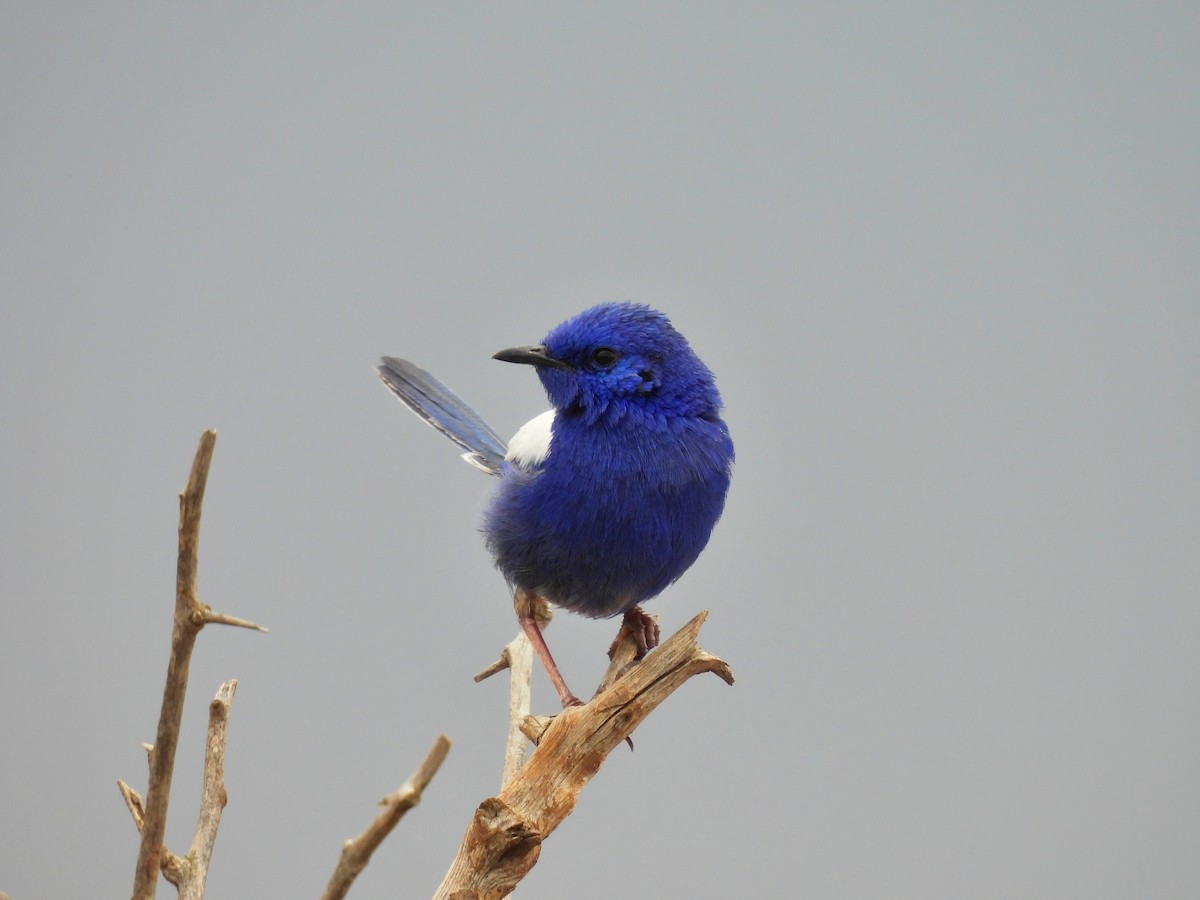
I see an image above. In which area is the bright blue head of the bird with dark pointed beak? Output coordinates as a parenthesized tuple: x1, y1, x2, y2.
(496, 302, 721, 421)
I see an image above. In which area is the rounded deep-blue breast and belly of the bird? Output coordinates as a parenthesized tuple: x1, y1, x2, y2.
(485, 414, 732, 616)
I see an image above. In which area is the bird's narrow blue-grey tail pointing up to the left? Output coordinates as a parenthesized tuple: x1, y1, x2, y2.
(376, 356, 506, 475)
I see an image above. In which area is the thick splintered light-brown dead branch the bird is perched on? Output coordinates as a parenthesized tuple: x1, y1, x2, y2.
(434, 612, 733, 900)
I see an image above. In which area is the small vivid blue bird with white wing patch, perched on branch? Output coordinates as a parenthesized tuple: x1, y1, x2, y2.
(378, 302, 733, 708)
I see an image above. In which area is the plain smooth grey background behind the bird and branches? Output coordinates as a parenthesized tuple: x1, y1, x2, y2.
(0, 2, 1200, 900)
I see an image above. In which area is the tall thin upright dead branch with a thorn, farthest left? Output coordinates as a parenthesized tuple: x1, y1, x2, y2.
(121, 431, 265, 900)
